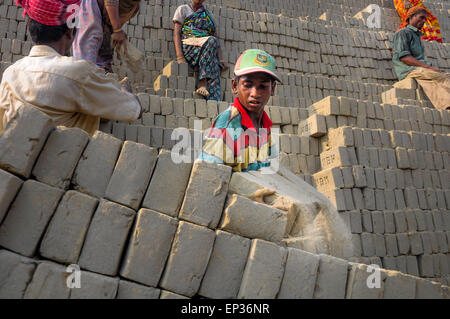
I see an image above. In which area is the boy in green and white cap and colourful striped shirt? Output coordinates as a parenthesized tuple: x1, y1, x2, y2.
(199, 49, 281, 172)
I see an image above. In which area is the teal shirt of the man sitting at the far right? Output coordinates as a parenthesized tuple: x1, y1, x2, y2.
(392, 24, 431, 80)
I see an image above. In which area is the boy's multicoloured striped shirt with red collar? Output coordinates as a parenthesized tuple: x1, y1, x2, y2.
(199, 98, 278, 172)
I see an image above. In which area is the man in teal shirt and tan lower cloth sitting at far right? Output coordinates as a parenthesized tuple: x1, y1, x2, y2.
(392, 7, 450, 110)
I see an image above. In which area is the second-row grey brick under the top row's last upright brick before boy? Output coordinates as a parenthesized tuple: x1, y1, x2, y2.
(159, 221, 215, 297)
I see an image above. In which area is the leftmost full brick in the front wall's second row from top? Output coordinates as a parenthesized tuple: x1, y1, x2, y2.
(0, 180, 63, 257)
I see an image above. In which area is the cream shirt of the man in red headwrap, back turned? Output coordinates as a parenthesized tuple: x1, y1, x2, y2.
(0, 45, 141, 135)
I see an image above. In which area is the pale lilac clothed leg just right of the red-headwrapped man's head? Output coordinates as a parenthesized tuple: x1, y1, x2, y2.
(72, 0, 103, 64)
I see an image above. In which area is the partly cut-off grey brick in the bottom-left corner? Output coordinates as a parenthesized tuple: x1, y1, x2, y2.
(0, 250, 36, 299)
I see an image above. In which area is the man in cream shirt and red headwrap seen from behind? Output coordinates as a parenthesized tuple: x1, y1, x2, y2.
(0, 0, 142, 135)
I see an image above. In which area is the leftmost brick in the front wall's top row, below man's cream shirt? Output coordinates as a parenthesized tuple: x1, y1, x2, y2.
(0, 106, 54, 178)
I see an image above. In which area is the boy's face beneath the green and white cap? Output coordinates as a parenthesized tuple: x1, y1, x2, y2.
(231, 72, 276, 113)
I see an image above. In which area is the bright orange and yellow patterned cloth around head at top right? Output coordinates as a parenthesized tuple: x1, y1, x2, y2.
(394, 0, 442, 43)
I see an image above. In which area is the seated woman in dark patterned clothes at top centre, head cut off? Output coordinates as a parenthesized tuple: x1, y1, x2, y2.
(173, 0, 228, 101)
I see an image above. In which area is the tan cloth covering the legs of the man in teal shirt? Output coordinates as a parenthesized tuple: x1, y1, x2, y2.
(407, 68, 450, 110)
